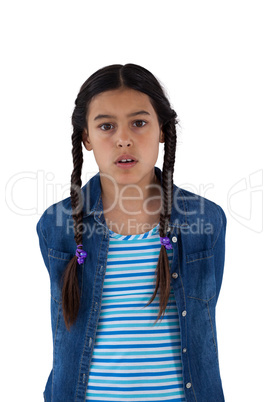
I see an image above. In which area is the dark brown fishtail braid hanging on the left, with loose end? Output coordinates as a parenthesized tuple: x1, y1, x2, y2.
(62, 128, 83, 329)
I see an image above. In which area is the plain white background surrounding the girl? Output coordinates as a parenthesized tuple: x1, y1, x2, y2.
(0, 0, 268, 402)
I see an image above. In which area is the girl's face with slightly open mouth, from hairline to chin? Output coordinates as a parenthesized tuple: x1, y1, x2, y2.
(83, 88, 164, 185)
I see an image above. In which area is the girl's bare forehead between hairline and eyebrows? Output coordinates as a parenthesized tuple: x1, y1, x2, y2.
(88, 88, 155, 118)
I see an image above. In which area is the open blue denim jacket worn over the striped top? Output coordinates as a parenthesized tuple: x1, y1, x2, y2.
(36, 166, 227, 402)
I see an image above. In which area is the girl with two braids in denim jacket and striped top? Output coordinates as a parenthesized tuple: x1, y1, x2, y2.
(37, 64, 226, 402)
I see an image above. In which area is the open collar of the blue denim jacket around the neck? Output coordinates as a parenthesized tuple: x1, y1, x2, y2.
(81, 166, 188, 227)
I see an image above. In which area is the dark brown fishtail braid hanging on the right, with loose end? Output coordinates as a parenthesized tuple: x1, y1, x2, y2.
(146, 114, 177, 321)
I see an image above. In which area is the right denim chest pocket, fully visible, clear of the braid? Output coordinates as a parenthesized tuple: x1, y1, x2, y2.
(186, 249, 216, 301)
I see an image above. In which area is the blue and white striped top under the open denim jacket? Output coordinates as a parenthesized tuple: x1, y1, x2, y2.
(86, 224, 186, 402)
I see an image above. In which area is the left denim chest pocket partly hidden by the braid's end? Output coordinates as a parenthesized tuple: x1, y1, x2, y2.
(48, 248, 74, 303)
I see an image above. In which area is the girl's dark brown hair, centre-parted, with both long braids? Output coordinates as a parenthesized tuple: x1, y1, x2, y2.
(62, 64, 179, 330)
